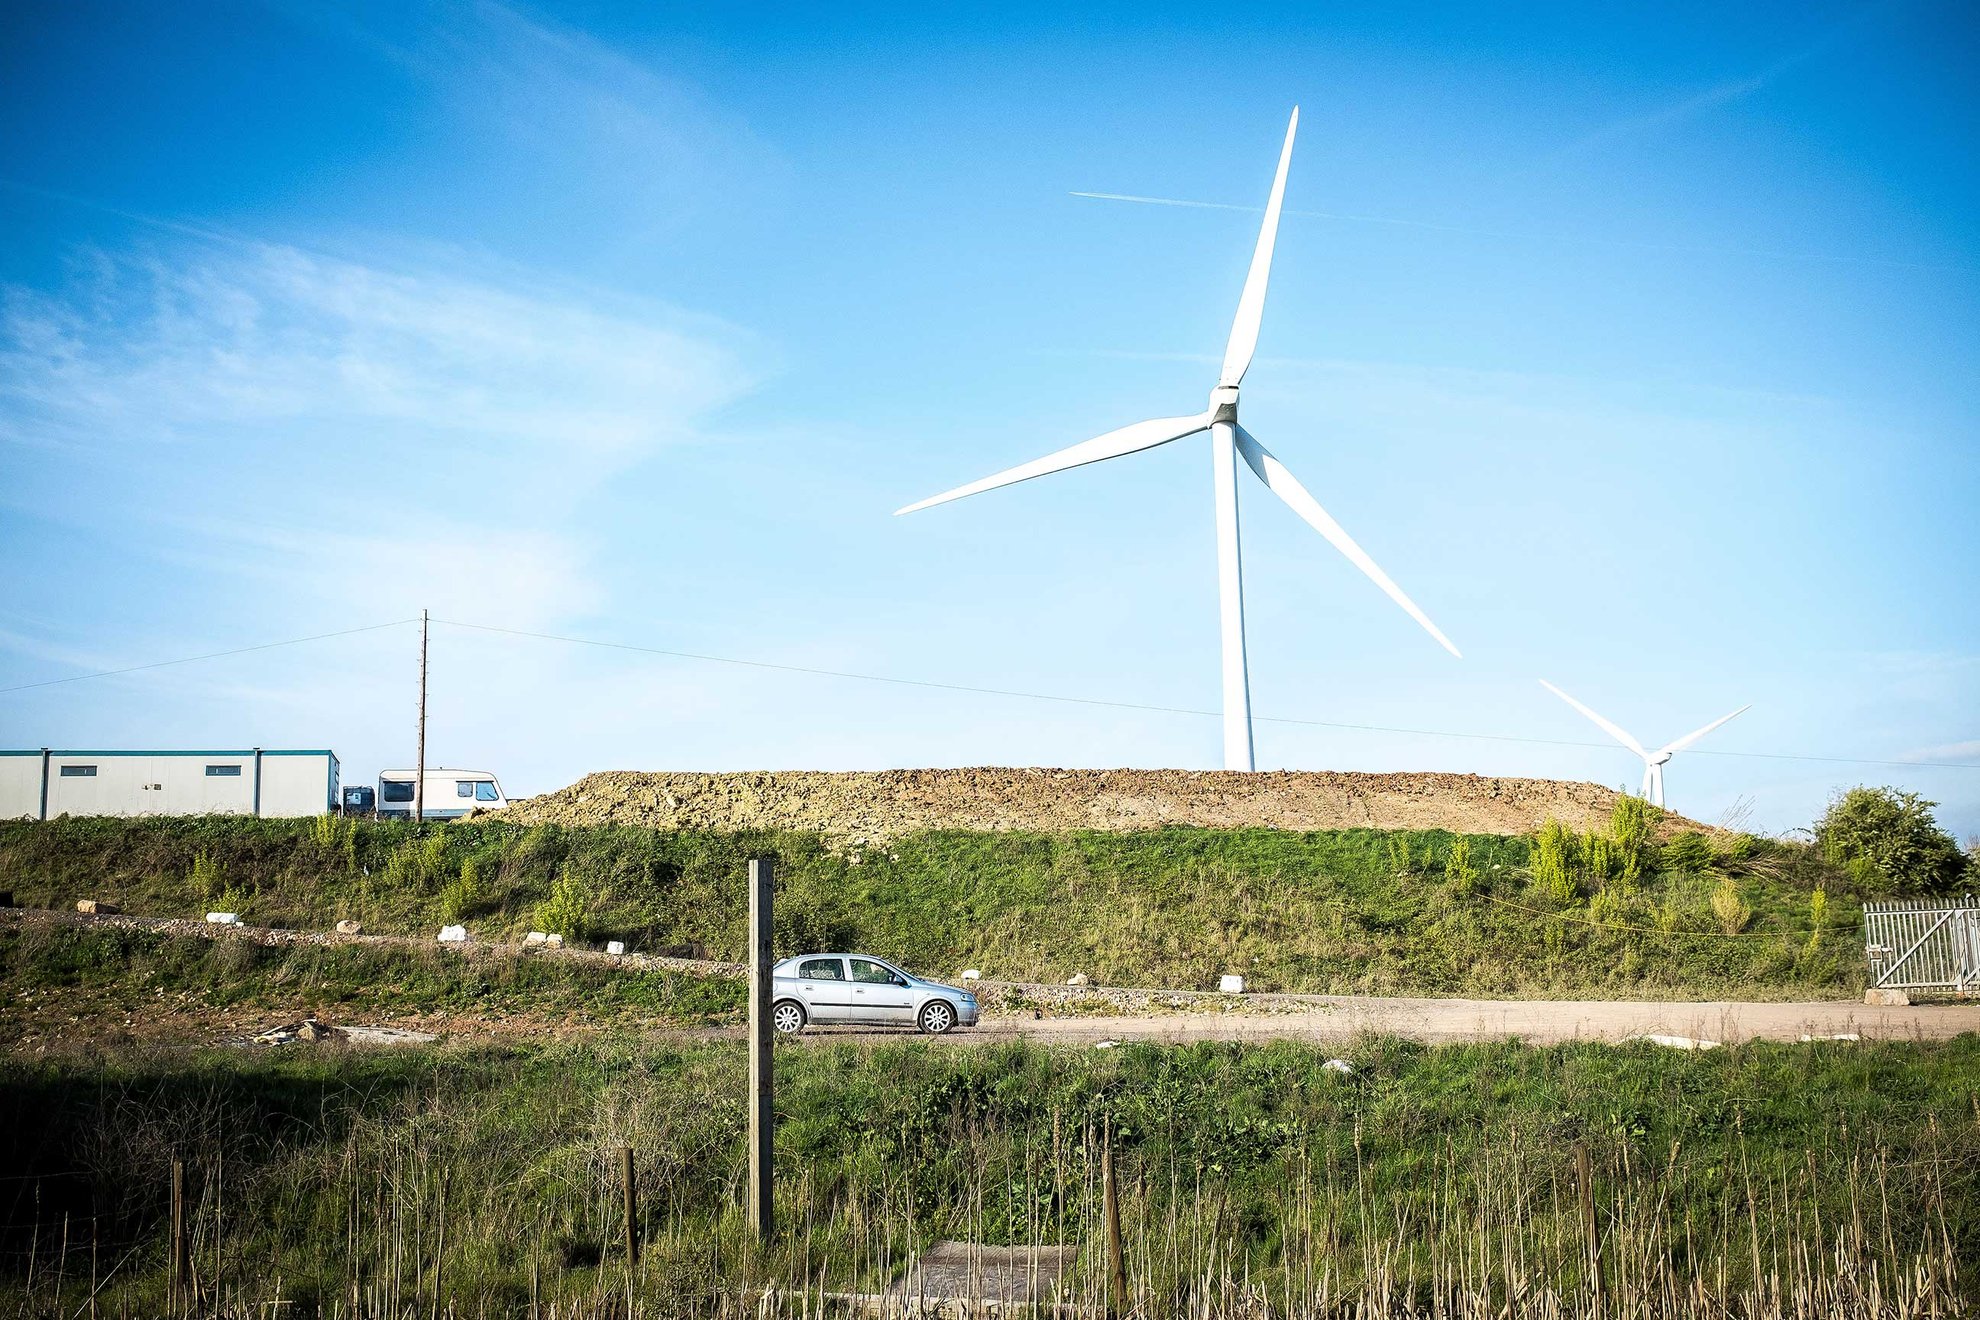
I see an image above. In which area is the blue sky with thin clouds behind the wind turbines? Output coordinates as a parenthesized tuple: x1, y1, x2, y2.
(0, 0, 1980, 835)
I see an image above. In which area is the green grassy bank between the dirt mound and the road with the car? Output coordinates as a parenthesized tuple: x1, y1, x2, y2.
(0, 817, 1861, 997)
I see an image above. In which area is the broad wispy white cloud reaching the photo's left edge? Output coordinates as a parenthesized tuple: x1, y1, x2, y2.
(0, 243, 754, 459)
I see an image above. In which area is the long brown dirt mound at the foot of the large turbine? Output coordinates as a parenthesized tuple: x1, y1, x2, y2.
(503, 768, 1647, 843)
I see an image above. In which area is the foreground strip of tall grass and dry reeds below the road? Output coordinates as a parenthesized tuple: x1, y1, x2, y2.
(0, 1037, 1980, 1320)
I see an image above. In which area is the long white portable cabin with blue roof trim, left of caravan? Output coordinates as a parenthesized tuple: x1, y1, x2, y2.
(0, 748, 339, 821)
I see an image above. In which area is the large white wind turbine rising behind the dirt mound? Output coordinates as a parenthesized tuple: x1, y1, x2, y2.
(895, 105, 1457, 770)
